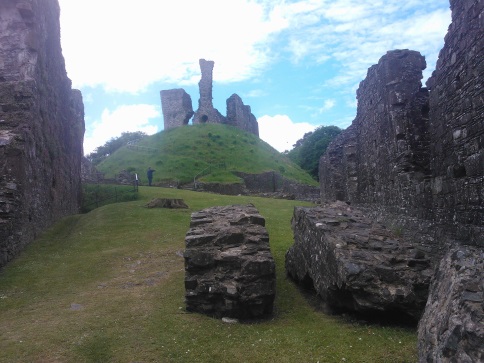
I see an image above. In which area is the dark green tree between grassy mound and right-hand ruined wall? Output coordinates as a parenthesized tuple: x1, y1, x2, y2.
(286, 126, 343, 180)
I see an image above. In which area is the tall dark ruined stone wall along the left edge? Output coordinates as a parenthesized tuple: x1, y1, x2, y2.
(0, 0, 84, 267)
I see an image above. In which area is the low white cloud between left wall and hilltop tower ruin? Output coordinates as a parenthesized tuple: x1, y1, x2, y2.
(84, 105, 161, 155)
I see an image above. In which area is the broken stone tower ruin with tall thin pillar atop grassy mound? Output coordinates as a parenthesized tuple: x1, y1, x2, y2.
(160, 59, 259, 136)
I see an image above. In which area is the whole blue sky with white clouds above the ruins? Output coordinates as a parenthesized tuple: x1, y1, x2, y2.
(59, 0, 451, 154)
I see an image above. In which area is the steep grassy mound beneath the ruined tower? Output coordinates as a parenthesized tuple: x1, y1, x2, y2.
(98, 124, 317, 185)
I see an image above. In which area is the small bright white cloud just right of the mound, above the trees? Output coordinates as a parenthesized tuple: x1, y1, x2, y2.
(257, 115, 316, 152)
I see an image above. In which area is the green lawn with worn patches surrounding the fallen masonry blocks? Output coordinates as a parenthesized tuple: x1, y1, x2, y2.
(0, 187, 417, 363)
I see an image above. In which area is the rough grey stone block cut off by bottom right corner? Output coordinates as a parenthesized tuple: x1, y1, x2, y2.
(418, 246, 484, 363)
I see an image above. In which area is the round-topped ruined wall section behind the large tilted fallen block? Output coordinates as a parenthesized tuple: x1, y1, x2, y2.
(320, 50, 431, 218)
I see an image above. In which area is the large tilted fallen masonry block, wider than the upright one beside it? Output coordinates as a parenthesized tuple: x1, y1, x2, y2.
(286, 202, 433, 320)
